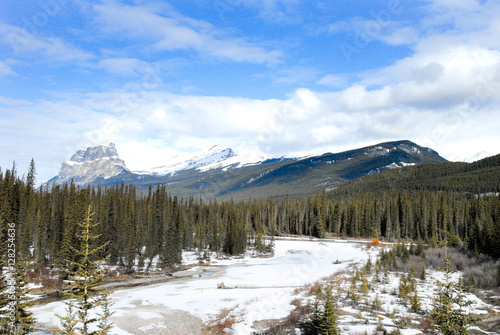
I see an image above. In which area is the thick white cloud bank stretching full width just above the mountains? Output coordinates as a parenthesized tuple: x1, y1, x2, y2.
(0, 73, 500, 181)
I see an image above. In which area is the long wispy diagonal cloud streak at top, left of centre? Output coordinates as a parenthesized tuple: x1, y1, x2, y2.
(94, 3, 281, 63)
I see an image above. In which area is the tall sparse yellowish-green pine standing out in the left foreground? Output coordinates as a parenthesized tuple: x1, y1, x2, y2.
(58, 206, 111, 335)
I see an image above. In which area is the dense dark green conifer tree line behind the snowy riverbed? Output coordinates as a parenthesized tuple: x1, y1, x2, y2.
(0, 164, 500, 278)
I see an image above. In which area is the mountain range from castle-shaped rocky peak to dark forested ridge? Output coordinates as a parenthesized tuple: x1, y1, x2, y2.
(49, 141, 446, 200)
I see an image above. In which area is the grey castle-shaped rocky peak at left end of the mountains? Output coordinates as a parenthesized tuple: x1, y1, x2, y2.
(48, 143, 129, 186)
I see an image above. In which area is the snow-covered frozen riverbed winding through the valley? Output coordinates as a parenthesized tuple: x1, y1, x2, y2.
(32, 240, 375, 334)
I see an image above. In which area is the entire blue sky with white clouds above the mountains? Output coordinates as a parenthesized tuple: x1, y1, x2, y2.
(0, 0, 500, 182)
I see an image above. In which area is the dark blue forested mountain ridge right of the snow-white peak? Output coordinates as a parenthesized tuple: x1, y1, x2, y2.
(199, 141, 446, 199)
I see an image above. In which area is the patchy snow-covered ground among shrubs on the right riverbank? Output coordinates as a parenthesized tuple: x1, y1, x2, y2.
(330, 270, 500, 335)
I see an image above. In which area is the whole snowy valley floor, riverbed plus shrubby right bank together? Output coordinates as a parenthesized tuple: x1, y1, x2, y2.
(32, 238, 500, 335)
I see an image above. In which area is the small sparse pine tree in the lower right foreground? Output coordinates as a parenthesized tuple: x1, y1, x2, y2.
(431, 256, 475, 335)
